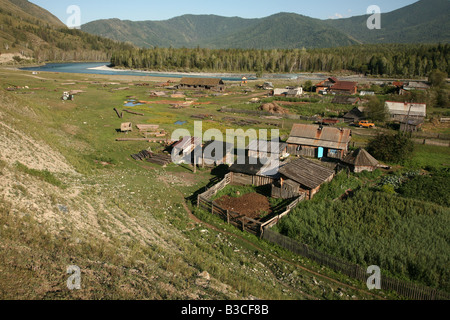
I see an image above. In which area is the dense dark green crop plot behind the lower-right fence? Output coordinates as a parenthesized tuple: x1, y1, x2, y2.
(275, 188, 450, 291)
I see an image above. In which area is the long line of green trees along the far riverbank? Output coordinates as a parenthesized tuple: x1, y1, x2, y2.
(111, 44, 450, 77)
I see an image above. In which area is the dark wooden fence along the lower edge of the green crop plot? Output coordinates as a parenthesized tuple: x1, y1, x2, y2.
(262, 227, 450, 300)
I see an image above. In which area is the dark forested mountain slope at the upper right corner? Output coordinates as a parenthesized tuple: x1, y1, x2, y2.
(325, 0, 450, 44)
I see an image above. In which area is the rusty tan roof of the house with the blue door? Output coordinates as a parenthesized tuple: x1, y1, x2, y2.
(287, 124, 351, 150)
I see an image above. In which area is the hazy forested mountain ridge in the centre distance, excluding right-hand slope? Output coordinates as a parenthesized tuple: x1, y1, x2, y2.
(81, 13, 357, 49)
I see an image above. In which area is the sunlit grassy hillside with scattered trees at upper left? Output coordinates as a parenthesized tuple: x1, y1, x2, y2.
(0, 0, 132, 63)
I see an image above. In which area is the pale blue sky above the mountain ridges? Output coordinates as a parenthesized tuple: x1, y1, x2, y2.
(30, 0, 418, 24)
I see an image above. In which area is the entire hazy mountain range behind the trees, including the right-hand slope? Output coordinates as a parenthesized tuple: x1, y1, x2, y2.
(82, 0, 450, 49)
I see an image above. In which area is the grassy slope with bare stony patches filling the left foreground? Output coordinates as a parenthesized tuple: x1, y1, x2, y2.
(0, 70, 390, 299)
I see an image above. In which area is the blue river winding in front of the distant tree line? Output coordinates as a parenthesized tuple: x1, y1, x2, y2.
(21, 62, 262, 81)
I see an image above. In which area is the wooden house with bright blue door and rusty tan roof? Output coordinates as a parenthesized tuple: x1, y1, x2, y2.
(287, 124, 352, 159)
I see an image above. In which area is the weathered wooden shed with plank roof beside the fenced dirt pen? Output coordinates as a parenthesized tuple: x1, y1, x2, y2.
(272, 157, 335, 200)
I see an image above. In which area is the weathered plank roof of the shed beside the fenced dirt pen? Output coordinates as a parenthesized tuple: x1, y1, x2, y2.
(280, 158, 334, 189)
